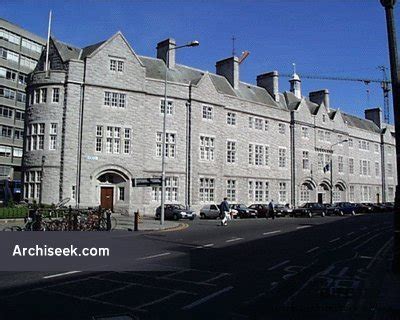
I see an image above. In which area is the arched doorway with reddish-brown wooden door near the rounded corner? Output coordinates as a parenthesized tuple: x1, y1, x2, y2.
(97, 170, 129, 211)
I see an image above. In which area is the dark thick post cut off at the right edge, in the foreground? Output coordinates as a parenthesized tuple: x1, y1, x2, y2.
(381, 0, 400, 274)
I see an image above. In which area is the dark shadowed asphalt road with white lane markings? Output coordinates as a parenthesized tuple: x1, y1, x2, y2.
(0, 213, 393, 320)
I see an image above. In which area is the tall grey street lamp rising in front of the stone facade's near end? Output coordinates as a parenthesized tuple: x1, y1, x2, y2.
(160, 40, 200, 225)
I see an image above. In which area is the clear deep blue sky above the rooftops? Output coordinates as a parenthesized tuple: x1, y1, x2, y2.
(0, 0, 400, 122)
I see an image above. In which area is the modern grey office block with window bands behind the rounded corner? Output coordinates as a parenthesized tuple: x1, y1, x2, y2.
(0, 18, 45, 190)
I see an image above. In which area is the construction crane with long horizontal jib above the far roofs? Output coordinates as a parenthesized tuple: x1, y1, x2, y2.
(280, 72, 391, 123)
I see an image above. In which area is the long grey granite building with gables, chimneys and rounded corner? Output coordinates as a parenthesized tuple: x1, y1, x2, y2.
(24, 32, 396, 215)
